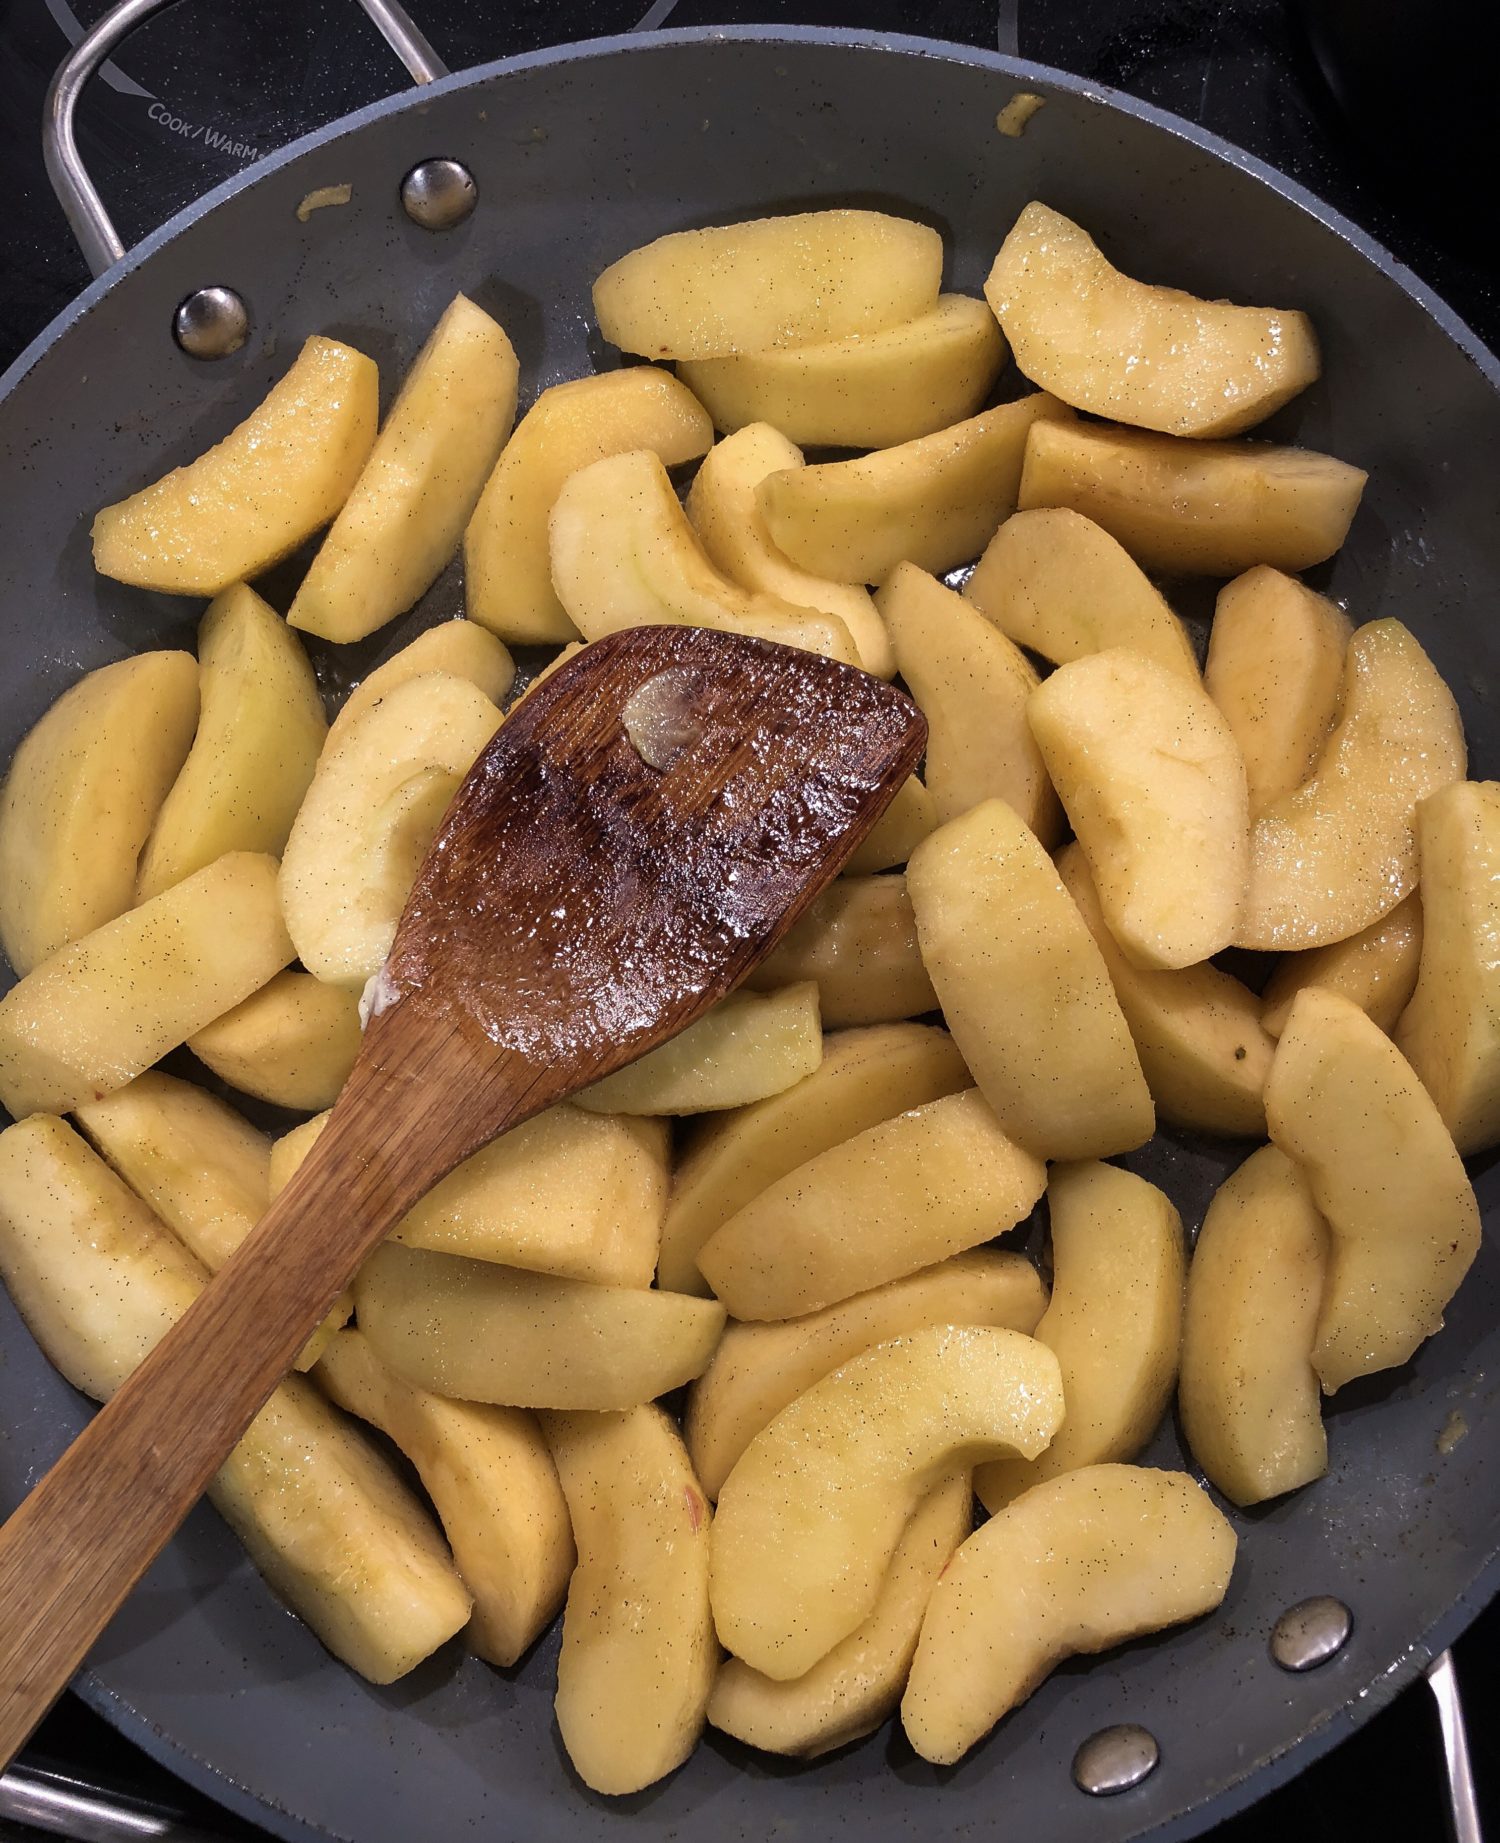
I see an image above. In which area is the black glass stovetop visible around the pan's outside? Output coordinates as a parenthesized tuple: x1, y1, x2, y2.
(0, 0, 1500, 1843)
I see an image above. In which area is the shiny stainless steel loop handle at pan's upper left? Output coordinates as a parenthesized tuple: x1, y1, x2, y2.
(42, 0, 448, 275)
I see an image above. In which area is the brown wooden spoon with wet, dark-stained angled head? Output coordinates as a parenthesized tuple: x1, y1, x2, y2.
(0, 627, 927, 1764)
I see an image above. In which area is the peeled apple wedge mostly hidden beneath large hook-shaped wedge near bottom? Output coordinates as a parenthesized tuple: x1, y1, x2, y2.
(708, 1473, 973, 1760)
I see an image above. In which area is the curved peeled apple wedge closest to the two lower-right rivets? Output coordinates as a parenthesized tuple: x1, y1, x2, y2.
(901, 1465, 1235, 1766)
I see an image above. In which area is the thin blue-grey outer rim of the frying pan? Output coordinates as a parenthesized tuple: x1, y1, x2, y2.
(0, 26, 1500, 1843)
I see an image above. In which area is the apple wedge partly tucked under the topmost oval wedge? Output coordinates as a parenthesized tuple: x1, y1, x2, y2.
(678, 295, 1006, 448)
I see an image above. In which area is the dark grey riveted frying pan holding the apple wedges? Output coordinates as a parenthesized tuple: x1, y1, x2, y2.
(0, 0, 1500, 1843)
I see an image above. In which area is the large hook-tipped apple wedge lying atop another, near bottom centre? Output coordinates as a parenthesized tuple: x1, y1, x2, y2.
(709, 1325, 1063, 1683)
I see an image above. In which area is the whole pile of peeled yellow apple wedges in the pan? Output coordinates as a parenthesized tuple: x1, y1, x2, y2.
(0, 194, 1500, 1793)
